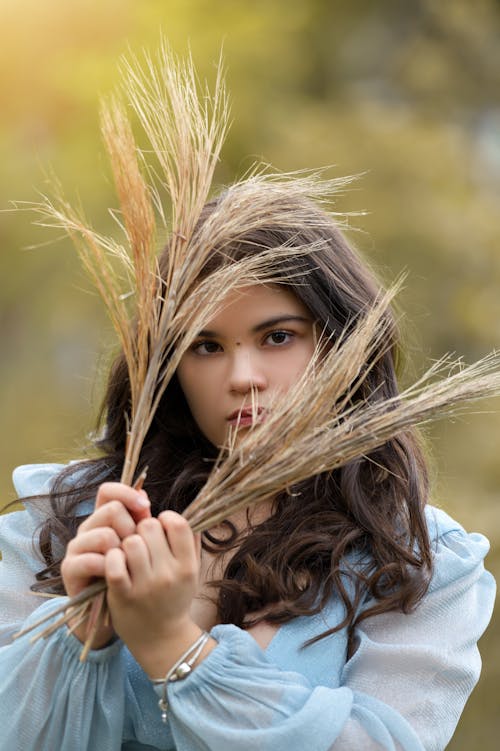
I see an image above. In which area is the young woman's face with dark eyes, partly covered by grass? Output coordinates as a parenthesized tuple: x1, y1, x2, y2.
(177, 284, 316, 446)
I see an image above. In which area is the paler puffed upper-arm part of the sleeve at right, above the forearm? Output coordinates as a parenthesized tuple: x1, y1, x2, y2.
(335, 509, 495, 751)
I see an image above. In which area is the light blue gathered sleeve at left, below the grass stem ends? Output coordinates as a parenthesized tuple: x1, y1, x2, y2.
(0, 598, 180, 751)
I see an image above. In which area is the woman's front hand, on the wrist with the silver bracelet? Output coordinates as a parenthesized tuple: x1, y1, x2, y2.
(105, 511, 206, 677)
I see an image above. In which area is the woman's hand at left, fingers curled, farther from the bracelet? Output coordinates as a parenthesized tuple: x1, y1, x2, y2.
(61, 482, 151, 649)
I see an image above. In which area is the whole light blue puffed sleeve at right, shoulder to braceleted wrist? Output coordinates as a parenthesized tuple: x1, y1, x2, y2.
(153, 508, 495, 751)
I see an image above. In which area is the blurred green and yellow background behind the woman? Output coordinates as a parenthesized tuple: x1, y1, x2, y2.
(0, 0, 500, 751)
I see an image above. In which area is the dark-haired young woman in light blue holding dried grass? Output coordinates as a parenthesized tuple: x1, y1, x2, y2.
(0, 180, 494, 751)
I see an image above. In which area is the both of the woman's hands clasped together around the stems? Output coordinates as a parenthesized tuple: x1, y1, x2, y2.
(61, 483, 215, 677)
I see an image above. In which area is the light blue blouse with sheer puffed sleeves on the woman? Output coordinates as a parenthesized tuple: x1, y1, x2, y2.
(0, 465, 495, 751)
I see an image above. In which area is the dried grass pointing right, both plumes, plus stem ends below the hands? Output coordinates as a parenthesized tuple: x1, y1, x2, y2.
(11, 340, 500, 652)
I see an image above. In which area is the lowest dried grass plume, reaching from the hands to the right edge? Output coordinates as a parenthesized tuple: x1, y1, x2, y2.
(185, 355, 500, 531)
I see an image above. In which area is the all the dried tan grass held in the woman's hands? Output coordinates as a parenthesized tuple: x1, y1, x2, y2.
(13, 45, 500, 659)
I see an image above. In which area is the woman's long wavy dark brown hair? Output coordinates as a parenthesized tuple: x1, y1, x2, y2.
(28, 183, 431, 638)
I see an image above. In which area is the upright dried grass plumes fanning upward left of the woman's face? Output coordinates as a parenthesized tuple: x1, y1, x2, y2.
(25, 44, 228, 494)
